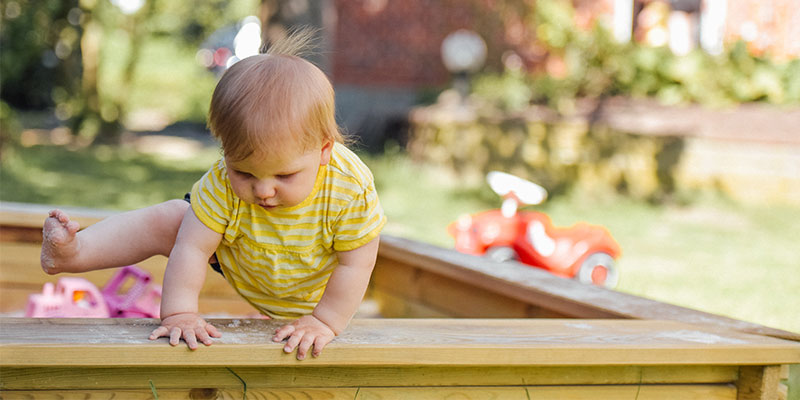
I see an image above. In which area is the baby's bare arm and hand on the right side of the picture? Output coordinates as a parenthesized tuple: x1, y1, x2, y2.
(272, 238, 380, 360)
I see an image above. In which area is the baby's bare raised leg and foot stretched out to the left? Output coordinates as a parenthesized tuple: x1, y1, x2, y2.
(41, 200, 189, 274)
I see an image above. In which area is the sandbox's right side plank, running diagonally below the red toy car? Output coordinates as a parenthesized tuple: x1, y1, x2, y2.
(375, 235, 800, 341)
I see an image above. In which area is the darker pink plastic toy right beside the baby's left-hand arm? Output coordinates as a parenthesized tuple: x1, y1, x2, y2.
(103, 265, 161, 318)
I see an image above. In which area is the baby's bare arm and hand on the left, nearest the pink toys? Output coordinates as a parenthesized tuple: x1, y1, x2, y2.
(150, 208, 222, 350)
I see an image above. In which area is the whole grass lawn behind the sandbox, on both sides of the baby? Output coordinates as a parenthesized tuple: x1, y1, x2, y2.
(0, 141, 800, 332)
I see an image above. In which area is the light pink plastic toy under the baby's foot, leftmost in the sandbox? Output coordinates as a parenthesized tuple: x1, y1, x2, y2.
(25, 277, 109, 318)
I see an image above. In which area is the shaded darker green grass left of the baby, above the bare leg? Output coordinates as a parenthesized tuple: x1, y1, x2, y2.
(0, 145, 214, 210)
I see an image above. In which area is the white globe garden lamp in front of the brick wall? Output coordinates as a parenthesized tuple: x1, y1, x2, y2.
(441, 29, 486, 99)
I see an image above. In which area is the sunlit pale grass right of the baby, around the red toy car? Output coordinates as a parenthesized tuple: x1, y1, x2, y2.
(368, 153, 800, 332)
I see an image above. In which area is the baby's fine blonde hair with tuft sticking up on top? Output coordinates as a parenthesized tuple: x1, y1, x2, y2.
(208, 29, 344, 161)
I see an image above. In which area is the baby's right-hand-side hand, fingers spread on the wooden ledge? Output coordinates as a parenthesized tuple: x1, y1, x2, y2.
(272, 315, 336, 360)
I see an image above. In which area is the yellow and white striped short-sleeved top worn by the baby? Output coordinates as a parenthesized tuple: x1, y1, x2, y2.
(191, 143, 386, 317)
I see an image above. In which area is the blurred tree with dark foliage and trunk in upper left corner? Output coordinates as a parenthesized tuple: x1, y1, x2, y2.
(0, 0, 258, 142)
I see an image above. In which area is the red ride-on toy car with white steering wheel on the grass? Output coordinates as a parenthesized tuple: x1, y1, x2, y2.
(448, 171, 621, 288)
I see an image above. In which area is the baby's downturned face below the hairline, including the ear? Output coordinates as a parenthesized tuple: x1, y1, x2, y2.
(225, 142, 333, 210)
